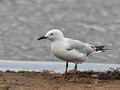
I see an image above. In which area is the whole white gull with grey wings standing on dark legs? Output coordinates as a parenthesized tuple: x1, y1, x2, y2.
(37, 29, 108, 79)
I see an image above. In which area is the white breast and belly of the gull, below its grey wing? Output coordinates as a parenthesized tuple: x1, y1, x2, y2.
(51, 42, 85, 63)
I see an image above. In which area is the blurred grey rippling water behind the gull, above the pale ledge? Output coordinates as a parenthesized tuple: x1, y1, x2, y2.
(0, 0, 120, 64)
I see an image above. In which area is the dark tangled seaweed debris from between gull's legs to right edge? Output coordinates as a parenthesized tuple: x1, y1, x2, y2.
(68, 68, 120, 80)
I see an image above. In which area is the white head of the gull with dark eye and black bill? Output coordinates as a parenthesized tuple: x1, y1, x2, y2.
(37, 29, 64, 42)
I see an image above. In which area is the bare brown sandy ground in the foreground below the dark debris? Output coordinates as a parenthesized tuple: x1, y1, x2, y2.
(0, 71, 120, 90)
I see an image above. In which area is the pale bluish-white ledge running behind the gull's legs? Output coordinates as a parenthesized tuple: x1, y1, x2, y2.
(0, 60, 120, 73)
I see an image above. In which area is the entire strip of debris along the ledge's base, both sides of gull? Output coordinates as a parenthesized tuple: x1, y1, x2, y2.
(1, 68, 120, 80)
